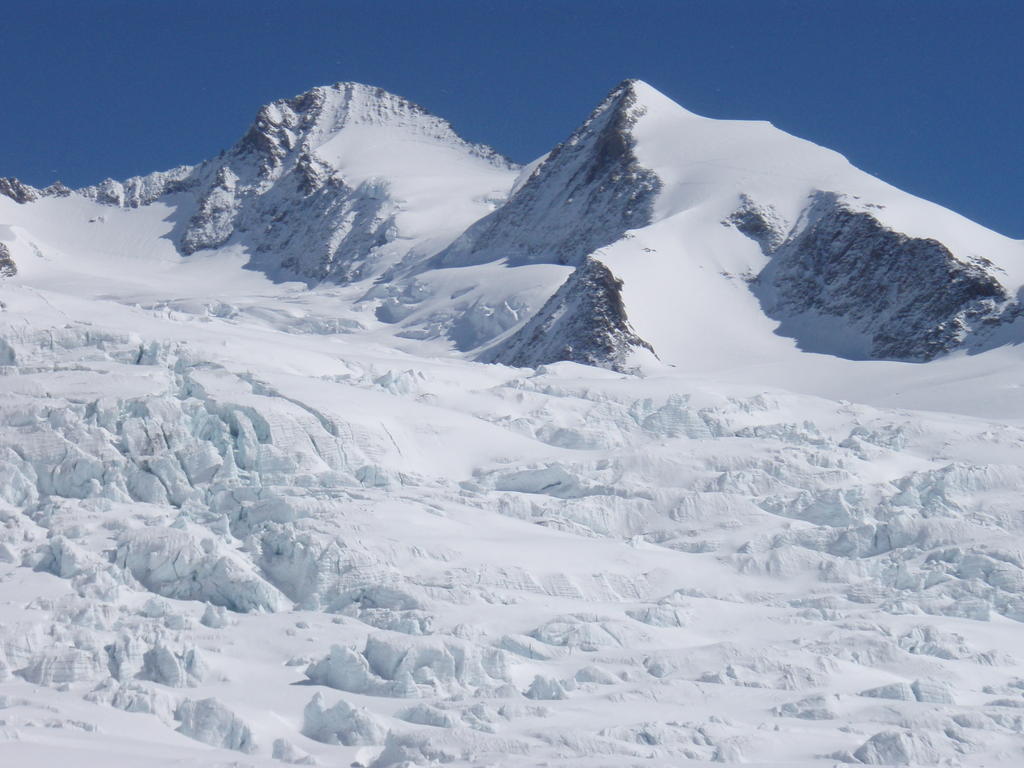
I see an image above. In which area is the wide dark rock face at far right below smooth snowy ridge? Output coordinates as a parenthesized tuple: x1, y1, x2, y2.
(745, 193, 1021, 361)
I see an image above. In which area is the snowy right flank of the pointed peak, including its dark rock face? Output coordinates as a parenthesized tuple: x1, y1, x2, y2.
(585, 85, 1024, 366)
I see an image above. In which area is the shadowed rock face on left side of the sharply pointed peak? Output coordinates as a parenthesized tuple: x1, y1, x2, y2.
(436, 80, 662, 266)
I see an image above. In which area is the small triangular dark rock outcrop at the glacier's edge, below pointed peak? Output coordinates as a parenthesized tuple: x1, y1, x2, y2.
(479, 258, 654, 371)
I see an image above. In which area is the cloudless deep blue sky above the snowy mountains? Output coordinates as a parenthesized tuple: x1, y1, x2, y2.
(0, 0, 1024, 238)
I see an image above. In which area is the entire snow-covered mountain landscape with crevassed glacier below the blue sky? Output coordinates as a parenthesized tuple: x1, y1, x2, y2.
(0, 80, 1024, 768)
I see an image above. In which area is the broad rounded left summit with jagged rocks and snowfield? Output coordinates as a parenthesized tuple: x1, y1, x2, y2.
(81, 83, 516, 283)
